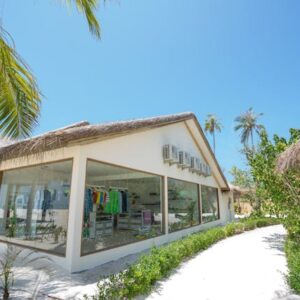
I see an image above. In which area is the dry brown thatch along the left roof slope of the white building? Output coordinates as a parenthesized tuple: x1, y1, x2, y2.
(0, 113, 196, 161)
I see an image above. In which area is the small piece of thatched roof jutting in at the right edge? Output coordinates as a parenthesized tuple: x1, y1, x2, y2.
(276, 140, 300, 173)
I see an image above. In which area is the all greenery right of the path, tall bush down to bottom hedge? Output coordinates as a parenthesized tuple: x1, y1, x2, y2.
(246, 129, 300, 293)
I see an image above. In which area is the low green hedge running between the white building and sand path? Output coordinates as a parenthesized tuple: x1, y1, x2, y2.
(85, 218, 280, 300)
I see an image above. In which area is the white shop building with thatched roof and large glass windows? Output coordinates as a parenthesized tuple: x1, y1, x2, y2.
(0, 113, 233, 272)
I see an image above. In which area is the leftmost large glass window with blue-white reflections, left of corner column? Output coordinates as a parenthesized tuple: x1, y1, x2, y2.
(0, 160, 72, 255)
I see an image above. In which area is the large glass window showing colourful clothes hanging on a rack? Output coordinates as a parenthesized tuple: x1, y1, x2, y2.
(81, 160, 162, 254)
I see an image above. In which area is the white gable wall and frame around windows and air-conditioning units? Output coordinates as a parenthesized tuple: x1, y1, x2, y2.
(0, 121, 233, 272)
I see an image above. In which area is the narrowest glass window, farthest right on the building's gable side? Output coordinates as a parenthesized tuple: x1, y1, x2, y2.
(201, 185, 219, 223)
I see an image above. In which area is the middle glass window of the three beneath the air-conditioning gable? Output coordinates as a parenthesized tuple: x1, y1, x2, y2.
(168, 178, 199, 232)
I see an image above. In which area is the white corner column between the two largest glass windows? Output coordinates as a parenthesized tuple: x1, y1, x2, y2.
(66, 151, 86, 272)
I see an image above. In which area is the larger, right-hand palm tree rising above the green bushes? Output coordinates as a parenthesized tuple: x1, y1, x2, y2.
(234, 107, 264, 150)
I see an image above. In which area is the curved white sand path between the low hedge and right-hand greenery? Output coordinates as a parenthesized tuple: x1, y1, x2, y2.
(146, 225, 300, 300)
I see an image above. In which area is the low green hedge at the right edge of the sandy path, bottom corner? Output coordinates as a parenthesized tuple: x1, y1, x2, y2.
(285, 238, 300, 294)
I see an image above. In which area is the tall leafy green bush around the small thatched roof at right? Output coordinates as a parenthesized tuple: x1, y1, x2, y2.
(246, 129, 300, 227)
